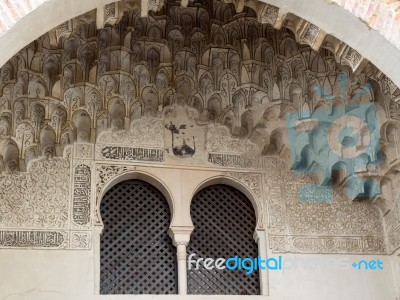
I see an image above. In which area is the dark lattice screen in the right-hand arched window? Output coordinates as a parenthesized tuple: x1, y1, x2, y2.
(188, 185, 260, 295)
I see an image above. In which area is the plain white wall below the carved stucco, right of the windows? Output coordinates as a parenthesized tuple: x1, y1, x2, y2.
(270, 254, 397, 300)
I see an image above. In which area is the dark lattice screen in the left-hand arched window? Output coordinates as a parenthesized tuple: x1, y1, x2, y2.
(100, 180, 177, 294)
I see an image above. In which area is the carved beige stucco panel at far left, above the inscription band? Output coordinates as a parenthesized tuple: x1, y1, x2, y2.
(0, 158, 70, 228)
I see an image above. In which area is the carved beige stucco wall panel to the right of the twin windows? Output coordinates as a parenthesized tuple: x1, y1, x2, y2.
(264, 159, 386, 253)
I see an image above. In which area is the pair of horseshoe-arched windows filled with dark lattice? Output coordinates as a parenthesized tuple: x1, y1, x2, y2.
(100, 180, 260, 295)
